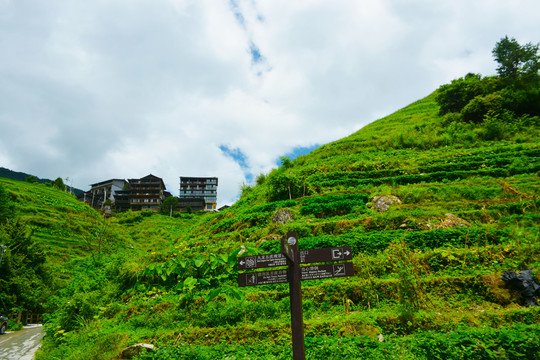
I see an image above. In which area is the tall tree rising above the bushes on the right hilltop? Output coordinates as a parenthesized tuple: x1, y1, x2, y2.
(493, 36, 540, 80)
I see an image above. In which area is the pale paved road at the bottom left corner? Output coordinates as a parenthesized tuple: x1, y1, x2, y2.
(0, 325, 45, 360)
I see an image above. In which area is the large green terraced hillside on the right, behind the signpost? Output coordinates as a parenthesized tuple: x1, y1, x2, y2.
(77, 92, 540, 359)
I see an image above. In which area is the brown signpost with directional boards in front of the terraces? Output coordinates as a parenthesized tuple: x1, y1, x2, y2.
(238, 232, 354, 360)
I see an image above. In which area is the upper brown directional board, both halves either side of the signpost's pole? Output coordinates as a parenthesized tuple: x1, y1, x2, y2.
(238, 244, 353, 270)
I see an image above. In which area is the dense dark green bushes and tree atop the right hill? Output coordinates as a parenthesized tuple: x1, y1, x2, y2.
(437, 37, 540, 127)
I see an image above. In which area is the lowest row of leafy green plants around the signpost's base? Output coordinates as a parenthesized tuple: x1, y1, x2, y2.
(137, 324, 540, 360)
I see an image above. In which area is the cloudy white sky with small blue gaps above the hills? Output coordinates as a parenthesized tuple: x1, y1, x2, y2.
(0, 0, 540, 207)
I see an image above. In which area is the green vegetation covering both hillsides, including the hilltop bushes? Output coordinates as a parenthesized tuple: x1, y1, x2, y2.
(0, 35, 540, 359)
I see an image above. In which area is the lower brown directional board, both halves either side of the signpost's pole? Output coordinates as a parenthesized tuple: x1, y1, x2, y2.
(238, 262, 354, 287)
